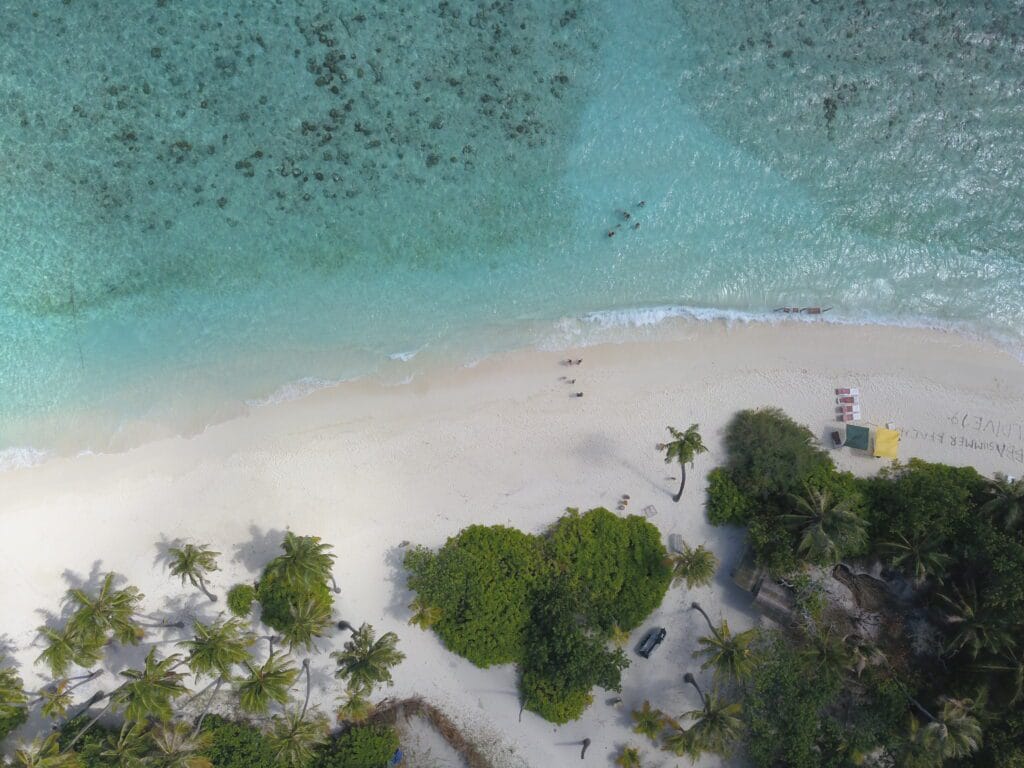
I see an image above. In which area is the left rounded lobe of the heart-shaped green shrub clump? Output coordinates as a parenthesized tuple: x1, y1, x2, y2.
(406, 525, 546, 667)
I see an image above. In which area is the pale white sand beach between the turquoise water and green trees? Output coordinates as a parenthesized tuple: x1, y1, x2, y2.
(0, 324, 1024, 768)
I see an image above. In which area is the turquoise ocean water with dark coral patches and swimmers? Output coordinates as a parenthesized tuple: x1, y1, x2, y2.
(0, 0, 1024, 466)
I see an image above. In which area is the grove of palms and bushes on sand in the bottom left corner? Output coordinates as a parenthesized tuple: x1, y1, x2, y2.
(0, 534, 421, 768)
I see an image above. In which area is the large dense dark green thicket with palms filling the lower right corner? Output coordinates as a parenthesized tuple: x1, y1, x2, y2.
(704, 410, 1024, 768)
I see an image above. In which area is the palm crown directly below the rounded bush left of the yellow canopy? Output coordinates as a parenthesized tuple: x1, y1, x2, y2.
(780, 487, 867, 565)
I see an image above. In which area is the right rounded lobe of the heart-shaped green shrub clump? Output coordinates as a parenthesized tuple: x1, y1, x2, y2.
(547, 507, 672, 636)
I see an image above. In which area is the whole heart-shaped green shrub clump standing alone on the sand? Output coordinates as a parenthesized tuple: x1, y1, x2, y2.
(406, 508, 672, 723)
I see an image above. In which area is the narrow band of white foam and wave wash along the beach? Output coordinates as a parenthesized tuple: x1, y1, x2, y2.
(0, 313, 1024, 475)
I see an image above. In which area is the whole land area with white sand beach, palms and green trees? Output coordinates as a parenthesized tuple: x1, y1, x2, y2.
(0, 321, 1024, 768)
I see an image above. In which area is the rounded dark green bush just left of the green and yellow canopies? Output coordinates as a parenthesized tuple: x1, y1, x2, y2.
(725, 408, 831, 499)
